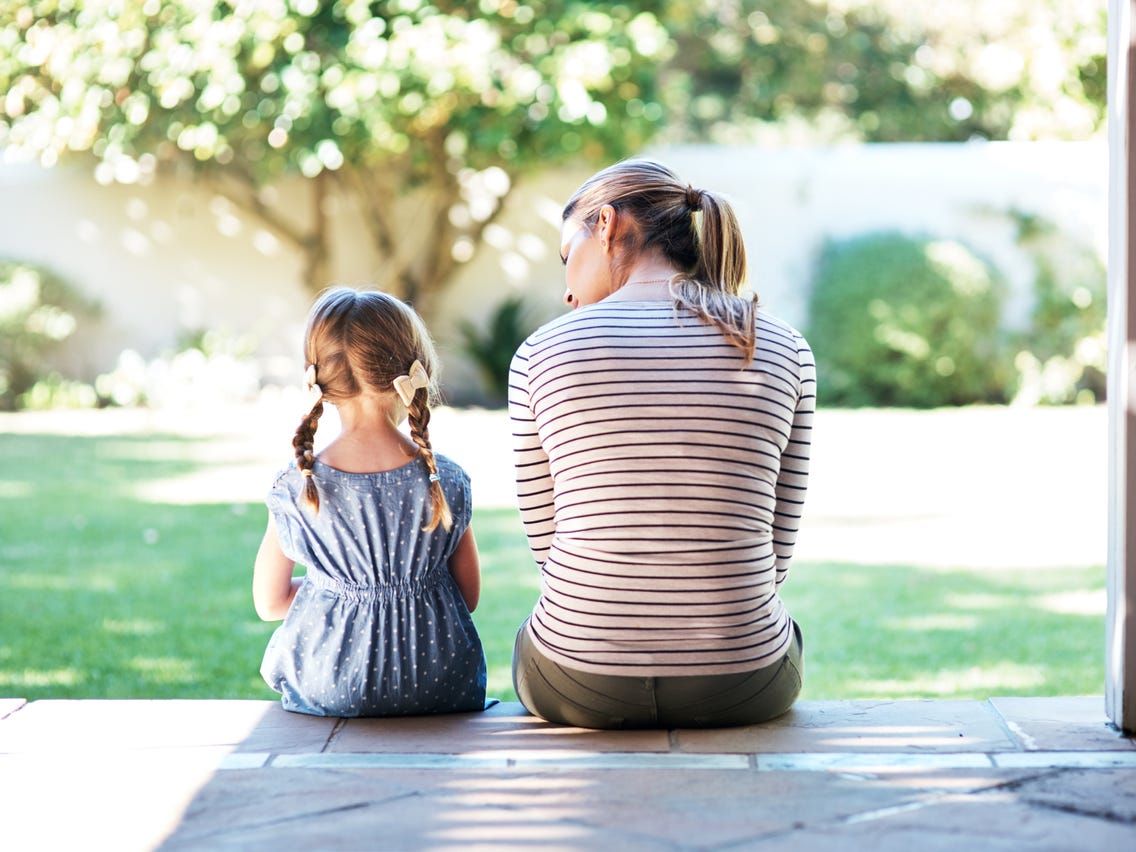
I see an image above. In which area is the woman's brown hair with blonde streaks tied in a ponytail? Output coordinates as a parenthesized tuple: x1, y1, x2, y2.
(563, 160, 758, 364)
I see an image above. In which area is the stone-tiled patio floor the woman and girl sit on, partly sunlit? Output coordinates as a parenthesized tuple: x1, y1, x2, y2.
(0, 696, 1136, 852)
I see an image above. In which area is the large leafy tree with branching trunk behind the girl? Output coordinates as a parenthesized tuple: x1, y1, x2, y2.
(0, 0, 668, 301)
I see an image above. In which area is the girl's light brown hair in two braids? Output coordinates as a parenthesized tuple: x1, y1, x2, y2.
(292, 287, 453, 529)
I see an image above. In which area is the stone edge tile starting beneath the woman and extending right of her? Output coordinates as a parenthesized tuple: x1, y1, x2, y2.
(676, 700, 1018, 754)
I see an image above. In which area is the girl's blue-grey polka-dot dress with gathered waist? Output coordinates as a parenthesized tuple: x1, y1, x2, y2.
(260, 456, 486, 717)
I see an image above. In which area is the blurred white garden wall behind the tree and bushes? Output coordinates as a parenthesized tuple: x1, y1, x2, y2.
(0, 143, 1108, 401)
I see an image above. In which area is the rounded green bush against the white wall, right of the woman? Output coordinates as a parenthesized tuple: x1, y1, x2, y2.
(808, 233, 1011, 408)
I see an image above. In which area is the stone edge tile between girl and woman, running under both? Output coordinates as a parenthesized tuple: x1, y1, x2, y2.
(327, 702, 670, 754)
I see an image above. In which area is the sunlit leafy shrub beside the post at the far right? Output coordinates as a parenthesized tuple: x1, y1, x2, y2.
(1012, 212, 1108, 404)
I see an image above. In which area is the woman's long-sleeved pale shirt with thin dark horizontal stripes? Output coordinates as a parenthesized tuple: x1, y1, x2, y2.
(509, 300, 816, 676)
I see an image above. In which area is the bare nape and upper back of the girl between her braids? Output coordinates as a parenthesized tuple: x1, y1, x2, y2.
(317, 394, 418, 474)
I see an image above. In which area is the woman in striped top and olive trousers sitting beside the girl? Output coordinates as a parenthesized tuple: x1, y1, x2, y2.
(510, 160, 816, 728)
